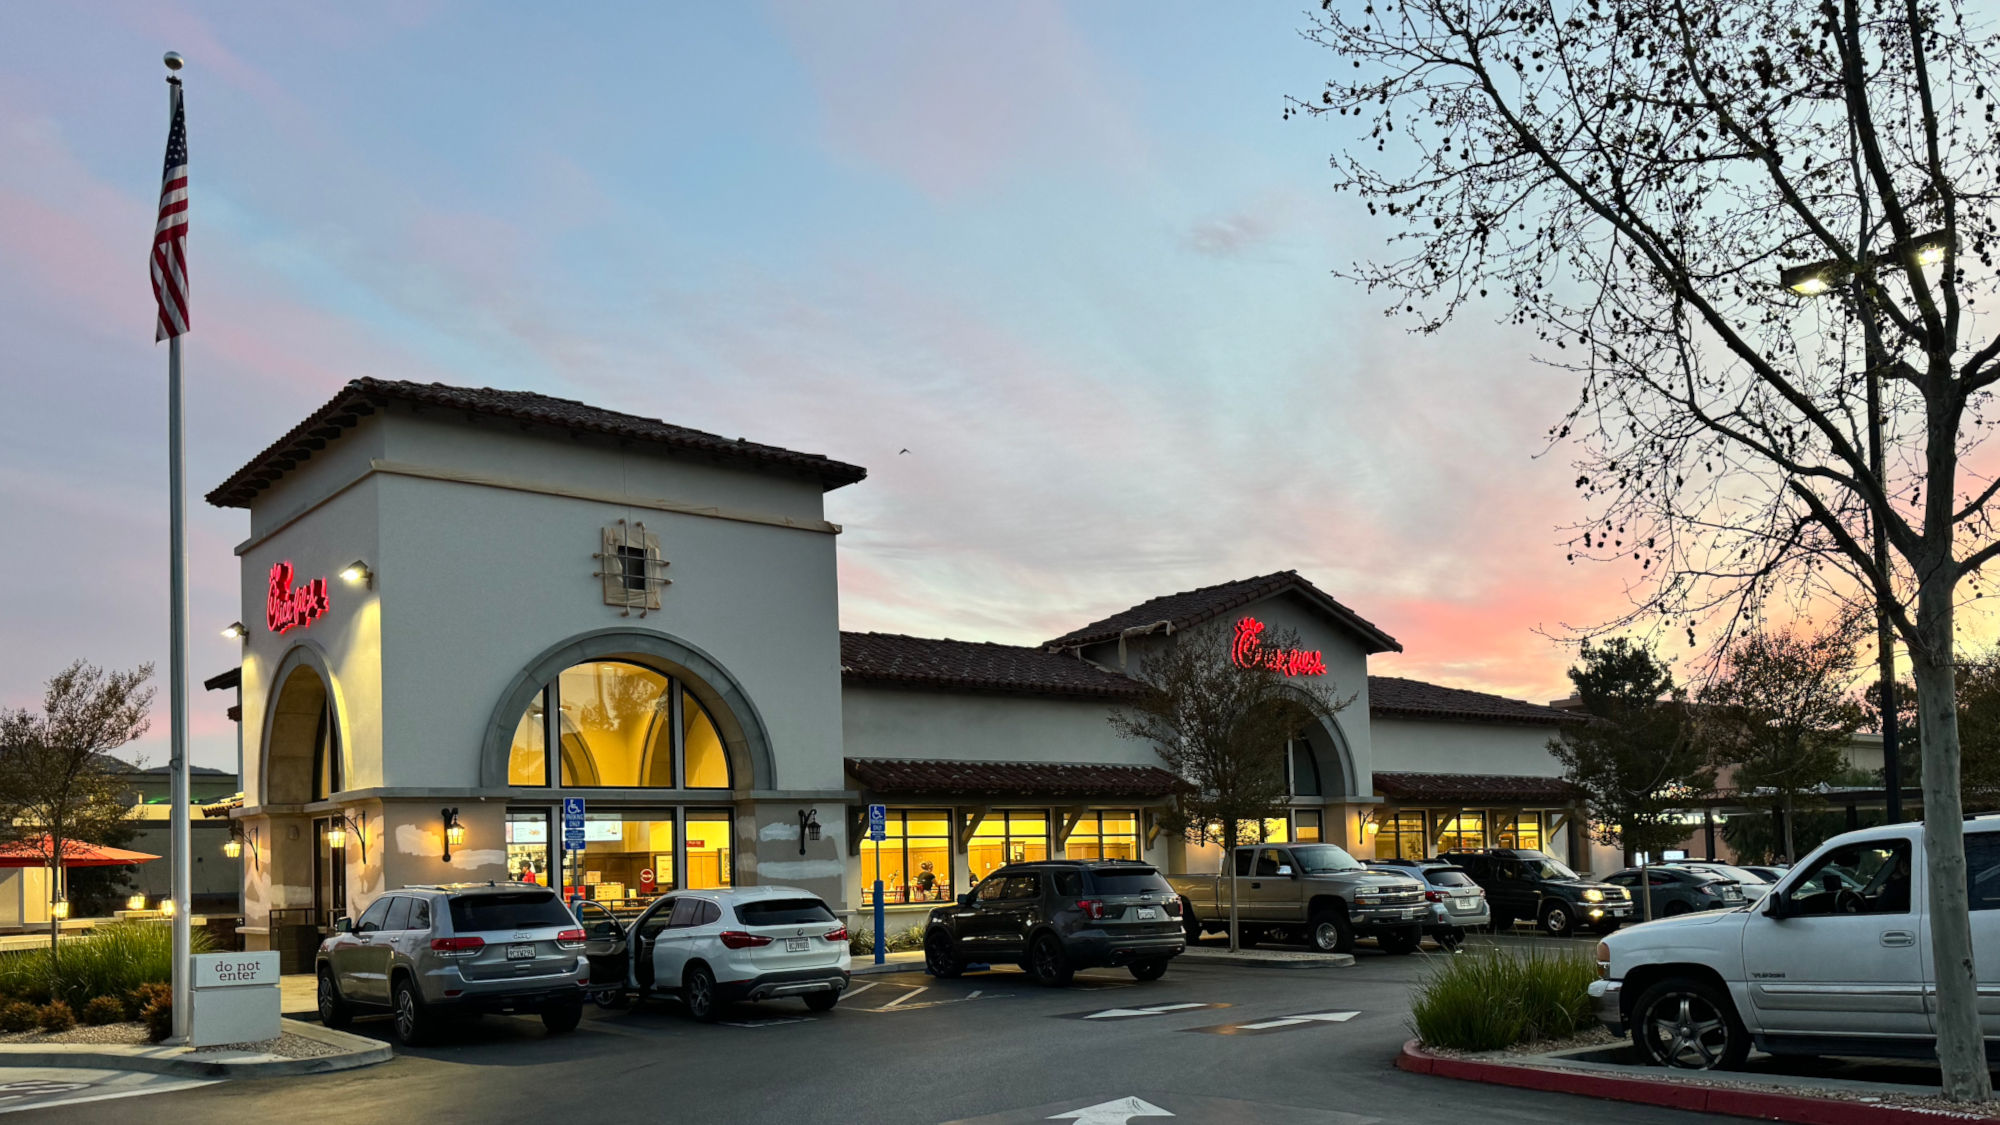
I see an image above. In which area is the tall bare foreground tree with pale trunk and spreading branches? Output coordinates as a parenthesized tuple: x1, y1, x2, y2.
(1290, 0, 2000, 1099)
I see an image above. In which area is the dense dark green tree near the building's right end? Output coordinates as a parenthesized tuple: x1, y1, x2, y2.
(1548, 637, 1716, 896)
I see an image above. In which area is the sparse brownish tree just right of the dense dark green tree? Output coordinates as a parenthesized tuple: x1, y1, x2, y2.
(1700, 619, 1862, 863)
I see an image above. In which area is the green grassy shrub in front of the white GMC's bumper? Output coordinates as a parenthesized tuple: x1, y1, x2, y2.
(1410, 951, 1598, 1051)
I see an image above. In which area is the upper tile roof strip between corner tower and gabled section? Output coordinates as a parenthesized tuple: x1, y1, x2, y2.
(840, 633, 1144, 699)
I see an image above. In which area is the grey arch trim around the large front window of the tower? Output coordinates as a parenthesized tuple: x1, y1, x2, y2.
(480, 627, 776, 791)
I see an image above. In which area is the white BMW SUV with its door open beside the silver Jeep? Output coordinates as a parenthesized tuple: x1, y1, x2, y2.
(576, 887, 848, 1023)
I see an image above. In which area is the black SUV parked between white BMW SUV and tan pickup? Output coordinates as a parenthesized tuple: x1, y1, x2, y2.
(924, 859, 1188, 987)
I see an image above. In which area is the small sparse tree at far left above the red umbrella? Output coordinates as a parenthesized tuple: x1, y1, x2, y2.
(0, 661, 152, 951)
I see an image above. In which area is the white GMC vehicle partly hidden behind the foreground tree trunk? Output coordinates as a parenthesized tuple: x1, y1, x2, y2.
(1590, 819, 2000, 1069)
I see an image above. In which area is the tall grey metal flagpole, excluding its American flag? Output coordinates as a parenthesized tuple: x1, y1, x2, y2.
(164, 52, 194, 1043)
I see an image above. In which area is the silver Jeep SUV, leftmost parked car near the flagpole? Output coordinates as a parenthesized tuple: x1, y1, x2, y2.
(316, 883, 590, 1045)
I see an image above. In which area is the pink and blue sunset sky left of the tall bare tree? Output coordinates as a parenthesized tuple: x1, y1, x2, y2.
(11, 0, 1768, 767)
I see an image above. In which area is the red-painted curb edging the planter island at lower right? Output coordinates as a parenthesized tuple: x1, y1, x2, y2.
(1396, 1039, 2000, 1125)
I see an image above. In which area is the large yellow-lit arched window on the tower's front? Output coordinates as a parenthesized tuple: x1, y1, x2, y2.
(508, 661, 730, 789)
